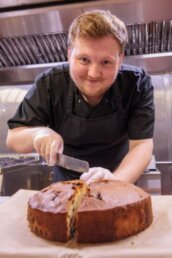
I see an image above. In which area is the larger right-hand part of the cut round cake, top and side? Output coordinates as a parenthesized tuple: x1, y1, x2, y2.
(76, 180, 153, 243)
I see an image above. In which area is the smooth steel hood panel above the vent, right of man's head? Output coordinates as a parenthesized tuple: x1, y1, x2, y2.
(83, 0, 172, 24)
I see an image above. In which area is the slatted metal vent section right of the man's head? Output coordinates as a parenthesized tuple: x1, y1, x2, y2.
(125, 20, 172, 56)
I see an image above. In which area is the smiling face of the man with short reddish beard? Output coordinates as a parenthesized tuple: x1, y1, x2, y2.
(68, 36, 123, 106)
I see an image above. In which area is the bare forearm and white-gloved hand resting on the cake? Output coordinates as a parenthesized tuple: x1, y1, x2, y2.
(80, 139, 153, 184)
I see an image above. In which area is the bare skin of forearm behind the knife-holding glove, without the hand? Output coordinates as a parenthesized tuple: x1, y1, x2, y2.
(6, 127, 46, 153)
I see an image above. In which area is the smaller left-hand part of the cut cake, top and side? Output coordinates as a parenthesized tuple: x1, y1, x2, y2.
(27, 180, 87, 242)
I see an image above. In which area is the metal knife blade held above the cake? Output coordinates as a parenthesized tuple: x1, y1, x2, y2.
(56, 153, 89, 173)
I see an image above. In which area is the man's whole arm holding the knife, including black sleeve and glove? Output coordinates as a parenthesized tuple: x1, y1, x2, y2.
(6, 69, 66, 164)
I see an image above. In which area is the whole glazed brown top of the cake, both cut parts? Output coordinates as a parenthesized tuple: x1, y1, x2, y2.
(29, 180, 149, 214)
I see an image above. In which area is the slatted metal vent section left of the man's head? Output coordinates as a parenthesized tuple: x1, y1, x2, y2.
(0, 33, 67, 67)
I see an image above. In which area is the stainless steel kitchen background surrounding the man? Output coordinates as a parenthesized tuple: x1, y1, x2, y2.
(0, 0, 172, 195)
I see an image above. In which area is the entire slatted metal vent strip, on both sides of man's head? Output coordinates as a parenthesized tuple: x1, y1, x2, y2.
(0, 20, 172, 67)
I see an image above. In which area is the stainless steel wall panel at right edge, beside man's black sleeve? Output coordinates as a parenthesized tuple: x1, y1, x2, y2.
(151, 73, 172, 194)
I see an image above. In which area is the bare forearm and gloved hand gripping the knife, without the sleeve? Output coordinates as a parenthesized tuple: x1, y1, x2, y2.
(6, 127, 63, 164)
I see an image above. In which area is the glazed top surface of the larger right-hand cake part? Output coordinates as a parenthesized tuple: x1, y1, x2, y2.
(78, 180, 149, 212)
